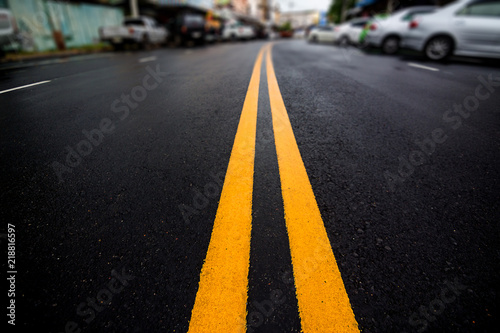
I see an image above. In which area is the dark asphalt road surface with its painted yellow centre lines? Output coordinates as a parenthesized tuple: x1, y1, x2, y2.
(0, 40, 500, 332)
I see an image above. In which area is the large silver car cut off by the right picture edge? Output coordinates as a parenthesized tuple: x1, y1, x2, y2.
(401, 0, 500, 60)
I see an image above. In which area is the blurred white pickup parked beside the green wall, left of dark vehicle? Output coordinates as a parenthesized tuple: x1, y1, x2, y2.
(99, 16, 168, 49)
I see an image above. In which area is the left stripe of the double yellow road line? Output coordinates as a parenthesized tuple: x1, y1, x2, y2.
(189, 45, 267, 333)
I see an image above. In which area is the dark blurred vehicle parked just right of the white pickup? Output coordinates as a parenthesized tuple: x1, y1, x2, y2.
(167, 13, 206, 46)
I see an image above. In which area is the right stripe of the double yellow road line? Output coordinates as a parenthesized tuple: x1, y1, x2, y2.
(266, 47, 359, 333)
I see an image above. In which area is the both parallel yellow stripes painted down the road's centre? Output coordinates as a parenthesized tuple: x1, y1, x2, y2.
(189, 44, 359, 333)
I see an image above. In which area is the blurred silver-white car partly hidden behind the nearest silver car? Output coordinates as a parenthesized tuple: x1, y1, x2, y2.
(364, 6, 436, 54)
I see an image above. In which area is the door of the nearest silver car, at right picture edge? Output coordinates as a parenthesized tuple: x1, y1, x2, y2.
(452, 0, 500, 54)
